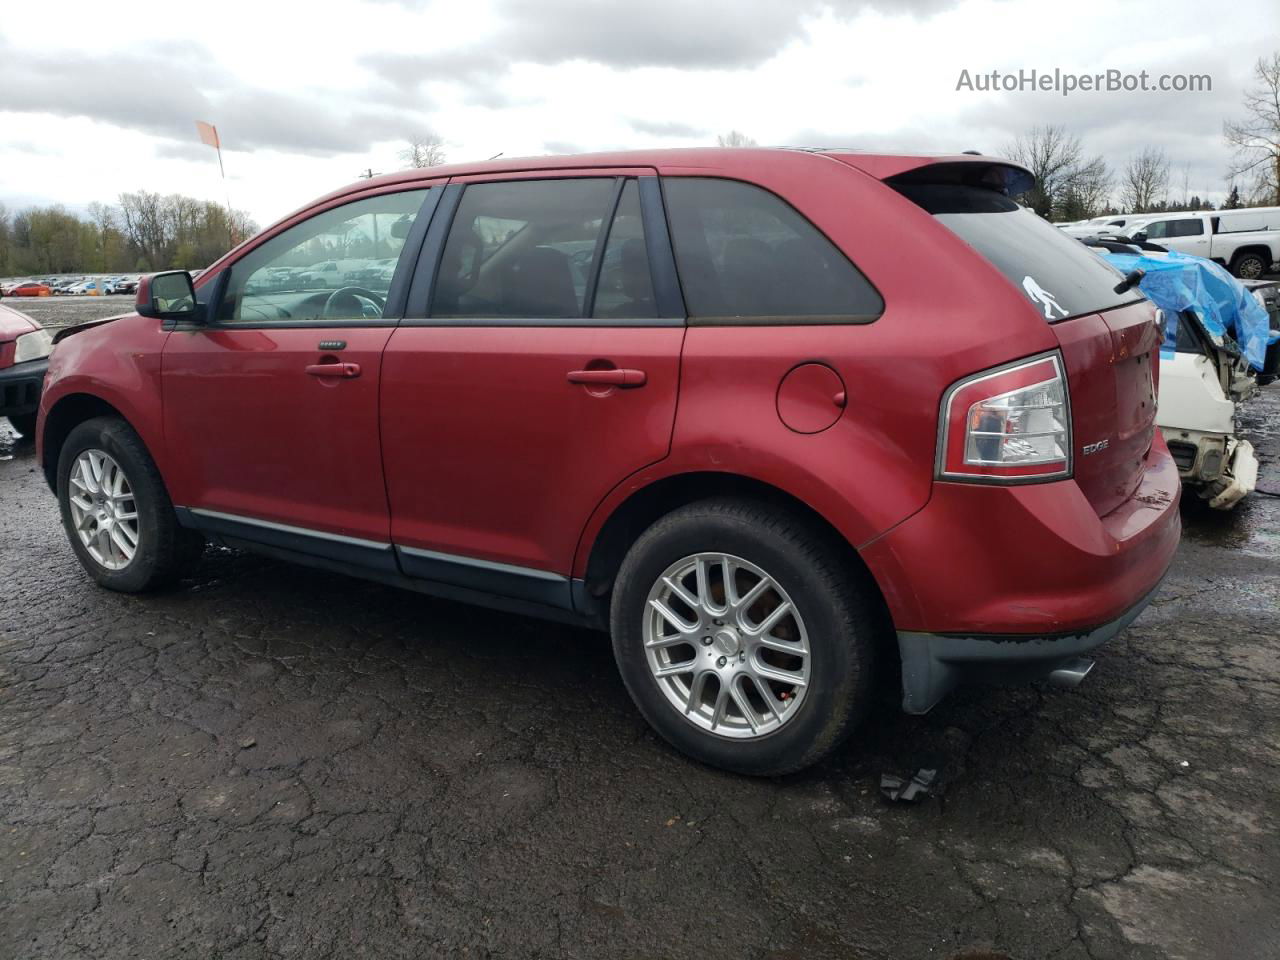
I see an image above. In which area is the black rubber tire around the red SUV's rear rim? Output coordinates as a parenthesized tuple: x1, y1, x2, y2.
(611, 498, 879, 776)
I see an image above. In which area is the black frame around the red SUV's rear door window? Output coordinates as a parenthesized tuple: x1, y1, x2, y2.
(399, 172, 685, 326)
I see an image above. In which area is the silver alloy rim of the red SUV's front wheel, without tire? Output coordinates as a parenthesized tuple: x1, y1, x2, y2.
(68, 449, 141, 570)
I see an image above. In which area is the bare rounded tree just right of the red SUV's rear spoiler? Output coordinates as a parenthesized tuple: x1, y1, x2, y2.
(1004, 125, 1111, 220)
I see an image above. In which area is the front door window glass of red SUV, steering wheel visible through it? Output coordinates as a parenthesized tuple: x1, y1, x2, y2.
(218, 189, 428, 324)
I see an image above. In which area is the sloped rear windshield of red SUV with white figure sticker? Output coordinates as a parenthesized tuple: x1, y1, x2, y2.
(890, 182, 1142, 321)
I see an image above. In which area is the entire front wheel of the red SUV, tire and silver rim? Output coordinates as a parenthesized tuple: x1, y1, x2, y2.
(58, 417, 204, 593)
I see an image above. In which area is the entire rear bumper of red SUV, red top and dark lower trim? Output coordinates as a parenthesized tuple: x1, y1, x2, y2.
(861, 434, 1181, 713)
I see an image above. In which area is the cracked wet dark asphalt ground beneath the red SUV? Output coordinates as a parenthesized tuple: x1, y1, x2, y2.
(0, 320, 1280, 960)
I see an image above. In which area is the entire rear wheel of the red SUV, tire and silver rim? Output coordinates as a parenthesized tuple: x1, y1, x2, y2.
(611, 499, 876, 776)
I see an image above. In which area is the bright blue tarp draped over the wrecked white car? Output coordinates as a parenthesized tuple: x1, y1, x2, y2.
(1100, 251, 1280, 370)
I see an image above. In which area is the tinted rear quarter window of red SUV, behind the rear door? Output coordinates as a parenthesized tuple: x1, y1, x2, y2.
(663, 177, 884, 323)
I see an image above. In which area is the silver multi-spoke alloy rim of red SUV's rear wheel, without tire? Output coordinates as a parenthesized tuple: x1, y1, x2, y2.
(644, 553, 812, 739)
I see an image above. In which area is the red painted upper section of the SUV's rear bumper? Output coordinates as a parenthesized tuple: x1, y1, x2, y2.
(860, 442, 1181, 637)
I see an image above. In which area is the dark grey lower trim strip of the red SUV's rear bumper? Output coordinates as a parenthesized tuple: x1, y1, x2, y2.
(897, 576, 1158, 713)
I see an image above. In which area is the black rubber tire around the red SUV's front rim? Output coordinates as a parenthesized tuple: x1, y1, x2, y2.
(58, 417, 205, 594)
